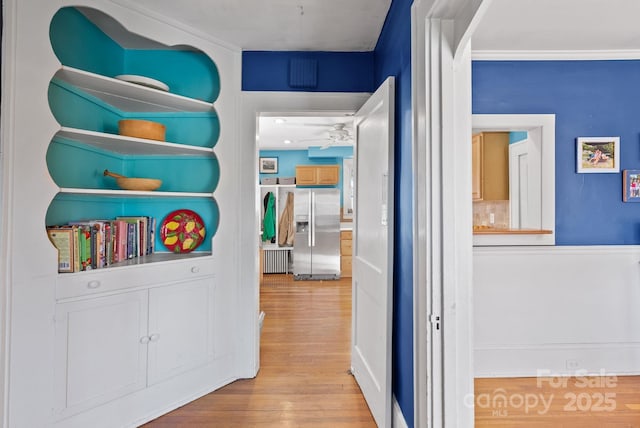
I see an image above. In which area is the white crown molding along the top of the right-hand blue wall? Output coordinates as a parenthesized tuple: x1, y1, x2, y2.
(472, 49, 640, 61)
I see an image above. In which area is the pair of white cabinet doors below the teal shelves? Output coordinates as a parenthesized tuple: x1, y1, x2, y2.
(55, 276, 214, 418)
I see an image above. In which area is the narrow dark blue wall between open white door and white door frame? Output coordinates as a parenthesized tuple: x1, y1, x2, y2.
(375, 0, 414, 427)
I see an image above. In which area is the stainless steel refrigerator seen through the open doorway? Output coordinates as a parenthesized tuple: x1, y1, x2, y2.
(293, 188, 340, 279)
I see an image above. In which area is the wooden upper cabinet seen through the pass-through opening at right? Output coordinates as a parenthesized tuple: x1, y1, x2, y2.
(471, 132, 509, 201)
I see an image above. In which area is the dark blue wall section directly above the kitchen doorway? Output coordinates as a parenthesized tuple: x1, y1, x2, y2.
(242, 51, 374, 92)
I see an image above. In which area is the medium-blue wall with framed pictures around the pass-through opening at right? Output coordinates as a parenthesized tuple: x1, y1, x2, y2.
(472, 61, 640, 245)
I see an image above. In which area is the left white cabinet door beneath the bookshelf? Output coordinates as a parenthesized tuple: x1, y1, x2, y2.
(55, 290, 148, 416)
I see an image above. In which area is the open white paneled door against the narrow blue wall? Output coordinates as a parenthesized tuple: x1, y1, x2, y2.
(351, 77, 395, 427)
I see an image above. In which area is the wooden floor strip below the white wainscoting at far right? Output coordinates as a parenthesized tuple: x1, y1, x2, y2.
(475, 375, 640, 428)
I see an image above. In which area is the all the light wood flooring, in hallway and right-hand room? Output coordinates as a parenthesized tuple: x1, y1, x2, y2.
(145, 275, 640, 428)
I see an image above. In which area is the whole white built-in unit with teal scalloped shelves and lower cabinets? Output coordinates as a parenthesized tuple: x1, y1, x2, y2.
(2, 4, 239, 428)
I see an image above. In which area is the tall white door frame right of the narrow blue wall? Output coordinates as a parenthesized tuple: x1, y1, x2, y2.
(411, 0, 491, 428)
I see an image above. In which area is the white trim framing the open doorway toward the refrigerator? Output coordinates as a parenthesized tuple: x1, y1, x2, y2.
(239, 92, 371, 378)
